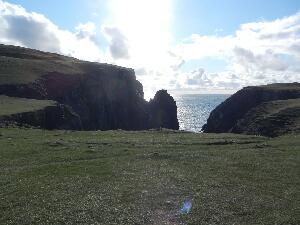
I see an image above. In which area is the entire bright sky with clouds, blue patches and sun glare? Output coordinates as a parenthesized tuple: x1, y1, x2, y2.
(0, 0, 300, 98)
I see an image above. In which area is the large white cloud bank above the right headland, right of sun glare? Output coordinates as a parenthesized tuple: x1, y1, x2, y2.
(174, 12, 300, 92)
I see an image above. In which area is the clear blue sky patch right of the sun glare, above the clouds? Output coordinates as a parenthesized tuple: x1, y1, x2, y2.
(175, 0, 300, 38)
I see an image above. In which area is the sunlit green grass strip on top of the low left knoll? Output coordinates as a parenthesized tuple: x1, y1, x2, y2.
(0, 95, 55, 116)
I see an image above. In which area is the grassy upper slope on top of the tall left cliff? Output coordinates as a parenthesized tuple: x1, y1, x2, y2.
(0, 45, 82, 85)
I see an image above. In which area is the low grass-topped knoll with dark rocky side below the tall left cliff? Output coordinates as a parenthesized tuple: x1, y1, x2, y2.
(0, 95, 82, 130)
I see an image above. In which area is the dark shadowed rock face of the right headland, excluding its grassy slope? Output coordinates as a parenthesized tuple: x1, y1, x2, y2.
(202, 83, 300, 136)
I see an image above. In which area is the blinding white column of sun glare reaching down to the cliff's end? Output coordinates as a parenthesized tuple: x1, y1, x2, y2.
(108, 0, 177, 99)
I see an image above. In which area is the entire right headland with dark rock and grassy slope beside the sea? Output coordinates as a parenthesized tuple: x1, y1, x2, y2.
(202, 83, 300, 137)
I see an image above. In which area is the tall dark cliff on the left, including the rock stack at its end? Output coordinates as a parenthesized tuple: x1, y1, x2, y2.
(0, 45, 178, 130)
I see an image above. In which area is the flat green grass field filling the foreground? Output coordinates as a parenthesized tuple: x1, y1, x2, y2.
(0, 128, 300, 225)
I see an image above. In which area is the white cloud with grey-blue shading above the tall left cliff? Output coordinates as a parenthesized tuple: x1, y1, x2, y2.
(0, 1, 102, 61)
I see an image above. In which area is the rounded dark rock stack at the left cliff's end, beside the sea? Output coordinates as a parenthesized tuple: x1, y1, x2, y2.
(149, 90, 179, 130)
